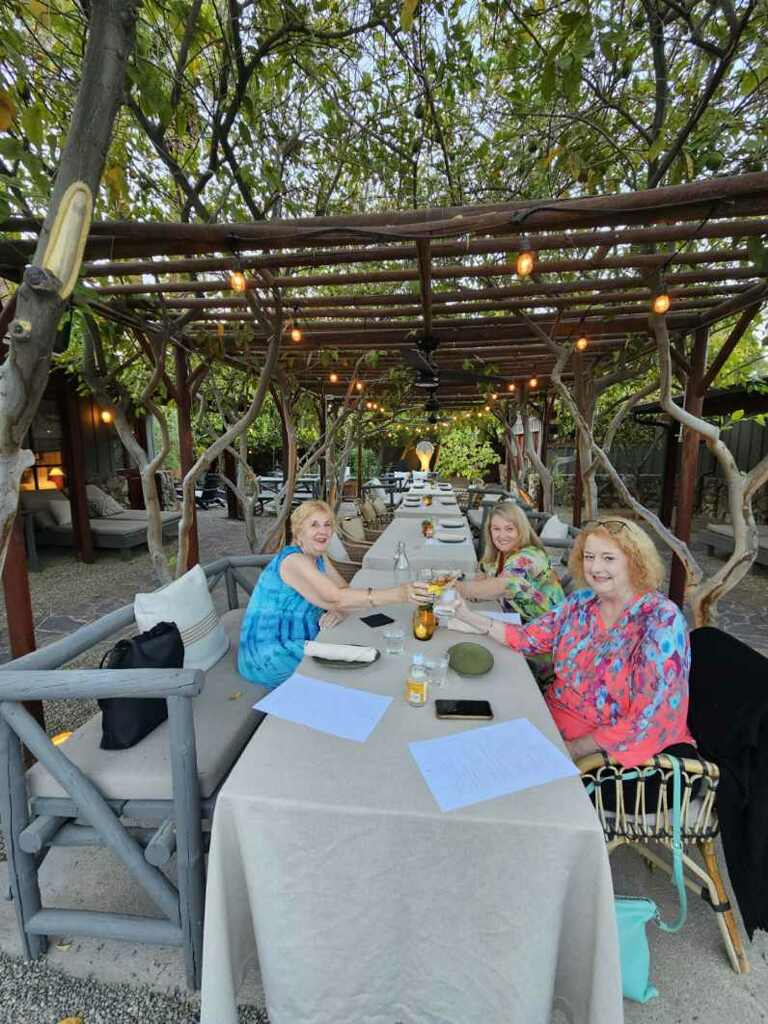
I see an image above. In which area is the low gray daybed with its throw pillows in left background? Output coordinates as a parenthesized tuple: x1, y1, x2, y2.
(19, 483, 181, 550)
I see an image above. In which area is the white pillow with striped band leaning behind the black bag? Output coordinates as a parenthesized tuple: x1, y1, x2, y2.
(133, 565, 229, 671)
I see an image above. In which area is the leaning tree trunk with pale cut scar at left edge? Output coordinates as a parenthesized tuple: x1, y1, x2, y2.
(0, 0, 137, 569)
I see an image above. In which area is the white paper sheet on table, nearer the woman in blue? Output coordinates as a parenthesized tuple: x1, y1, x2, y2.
(253, 672, 392, 743)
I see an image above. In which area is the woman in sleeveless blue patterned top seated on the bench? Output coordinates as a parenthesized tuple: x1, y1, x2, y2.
(238, 502, 412, 689)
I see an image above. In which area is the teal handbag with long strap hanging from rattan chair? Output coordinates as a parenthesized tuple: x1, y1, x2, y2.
(588, 754, 688, 1002)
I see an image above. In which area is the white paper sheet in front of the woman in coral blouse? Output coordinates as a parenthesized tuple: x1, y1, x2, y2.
(409, 718, 579, 811)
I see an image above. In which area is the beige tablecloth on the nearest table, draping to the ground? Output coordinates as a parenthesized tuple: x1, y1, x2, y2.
(201, 570, 623, 1024)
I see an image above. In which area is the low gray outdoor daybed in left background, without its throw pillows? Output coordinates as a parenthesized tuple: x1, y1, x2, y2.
(19, 485, 181, 551)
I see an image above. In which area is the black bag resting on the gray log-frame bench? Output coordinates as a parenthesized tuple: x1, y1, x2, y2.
(98, 623, 184, 751)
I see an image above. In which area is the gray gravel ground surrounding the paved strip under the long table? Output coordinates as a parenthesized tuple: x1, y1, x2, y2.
(0, 510, 768, 1024)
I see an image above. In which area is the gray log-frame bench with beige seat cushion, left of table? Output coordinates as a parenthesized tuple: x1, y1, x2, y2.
(0, 555, 271, 988)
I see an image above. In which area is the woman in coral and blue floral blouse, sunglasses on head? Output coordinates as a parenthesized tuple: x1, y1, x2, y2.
(442, 517, 695, 766)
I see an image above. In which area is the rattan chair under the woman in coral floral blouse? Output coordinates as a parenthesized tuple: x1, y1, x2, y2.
(577, 754, 750, 974)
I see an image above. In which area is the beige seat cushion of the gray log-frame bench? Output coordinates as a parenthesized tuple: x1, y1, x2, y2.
(27, 608, 266, 800)
